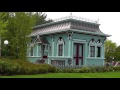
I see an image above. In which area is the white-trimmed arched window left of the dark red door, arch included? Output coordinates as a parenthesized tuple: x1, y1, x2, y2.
(57, 37, 65, 56)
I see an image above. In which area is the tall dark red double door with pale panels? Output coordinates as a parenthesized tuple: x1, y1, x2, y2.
(74, 43, 83, 65)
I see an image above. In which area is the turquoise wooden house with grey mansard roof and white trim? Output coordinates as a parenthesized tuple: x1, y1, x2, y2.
(27, 15, 110, 66)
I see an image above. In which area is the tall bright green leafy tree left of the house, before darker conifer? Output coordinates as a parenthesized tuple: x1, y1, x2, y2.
(4, 12, 35, 59)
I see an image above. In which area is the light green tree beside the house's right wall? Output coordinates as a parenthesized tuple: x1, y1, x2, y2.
(105, 40, 117, 61)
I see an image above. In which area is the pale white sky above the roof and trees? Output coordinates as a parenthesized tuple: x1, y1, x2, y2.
(45, 12, 120, 45)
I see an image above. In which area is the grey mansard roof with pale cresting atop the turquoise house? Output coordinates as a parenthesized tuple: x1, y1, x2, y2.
(30, 16, 110, 37)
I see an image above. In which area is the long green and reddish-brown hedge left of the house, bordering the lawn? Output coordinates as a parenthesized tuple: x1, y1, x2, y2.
(0, 58, 56, 75)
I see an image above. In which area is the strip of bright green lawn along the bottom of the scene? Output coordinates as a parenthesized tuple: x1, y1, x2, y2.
(0, 71, 120, 78)
